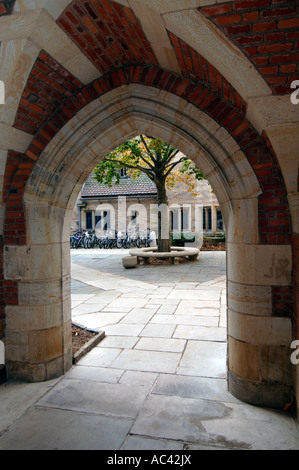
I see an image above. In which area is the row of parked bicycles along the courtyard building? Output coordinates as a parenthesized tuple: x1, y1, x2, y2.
(70, 227, 151, 249)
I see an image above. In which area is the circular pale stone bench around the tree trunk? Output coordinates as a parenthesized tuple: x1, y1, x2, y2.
(129, 246, 199, 263)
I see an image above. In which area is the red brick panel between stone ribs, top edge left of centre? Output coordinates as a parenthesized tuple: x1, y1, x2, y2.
(57, 0, 158, 73)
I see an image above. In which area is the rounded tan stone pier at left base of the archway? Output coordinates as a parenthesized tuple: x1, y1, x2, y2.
(5, 244, 72, 382)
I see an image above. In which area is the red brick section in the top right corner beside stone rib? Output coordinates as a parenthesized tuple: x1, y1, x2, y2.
(199, 0, 299, 94)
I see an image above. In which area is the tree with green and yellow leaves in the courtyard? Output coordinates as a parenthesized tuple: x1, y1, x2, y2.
(94, 135, 205, 253)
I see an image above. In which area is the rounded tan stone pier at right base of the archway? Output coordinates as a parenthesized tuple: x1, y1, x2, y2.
(227, 243, 292, 408)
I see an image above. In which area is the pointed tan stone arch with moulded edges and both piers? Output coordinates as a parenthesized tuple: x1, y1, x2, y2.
(4, 84, 291, 406)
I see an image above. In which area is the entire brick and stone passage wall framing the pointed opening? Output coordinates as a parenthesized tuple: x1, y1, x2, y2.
(0, 0, 299, 414)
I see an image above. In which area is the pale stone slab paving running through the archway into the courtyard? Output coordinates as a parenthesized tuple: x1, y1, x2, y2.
(0, 250, 299, 451)
